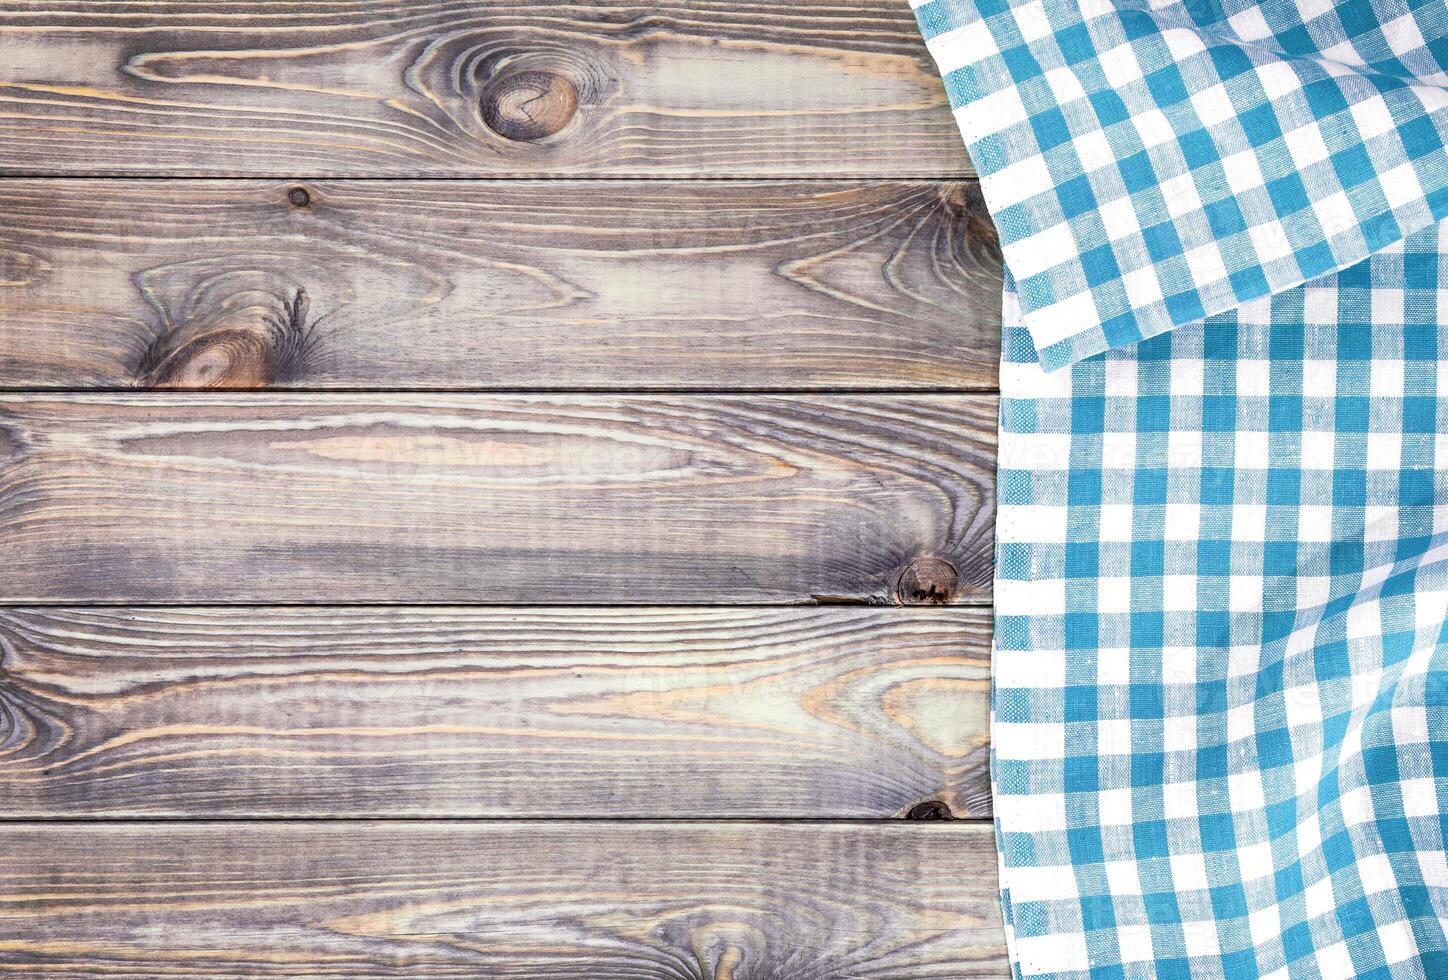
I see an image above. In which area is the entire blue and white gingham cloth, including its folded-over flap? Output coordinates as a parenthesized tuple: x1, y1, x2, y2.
(917, 0, 1448, 980)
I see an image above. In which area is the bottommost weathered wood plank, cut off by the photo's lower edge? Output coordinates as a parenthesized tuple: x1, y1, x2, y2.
(0, 821, 1009, 980)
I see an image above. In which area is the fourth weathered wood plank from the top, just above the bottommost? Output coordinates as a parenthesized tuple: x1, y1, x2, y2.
(0, 607, 990, 818)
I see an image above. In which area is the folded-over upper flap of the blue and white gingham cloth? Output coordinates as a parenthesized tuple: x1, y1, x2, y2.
(915, 0, 1448, 369)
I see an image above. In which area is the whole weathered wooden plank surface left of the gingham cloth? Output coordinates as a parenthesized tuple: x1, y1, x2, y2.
(0, 0, 1009, 980)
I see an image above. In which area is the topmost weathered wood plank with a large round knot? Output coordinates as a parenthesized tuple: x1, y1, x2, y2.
(0, 0, 969, 177)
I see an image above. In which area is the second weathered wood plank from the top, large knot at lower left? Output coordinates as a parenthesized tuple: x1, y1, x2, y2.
(0, 179, 1001, 389)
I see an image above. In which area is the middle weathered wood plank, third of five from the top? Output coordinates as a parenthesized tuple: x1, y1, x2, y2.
(0, 392, 996, 605)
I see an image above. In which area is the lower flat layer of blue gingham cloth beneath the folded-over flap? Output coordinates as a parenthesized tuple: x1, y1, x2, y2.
(992, 256, 1448, 980)
